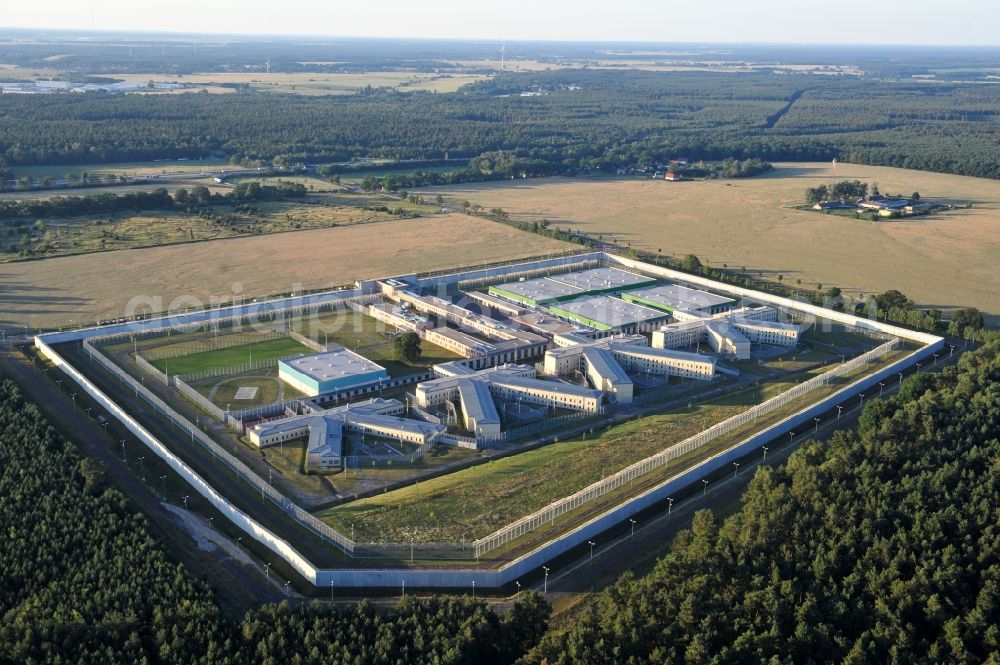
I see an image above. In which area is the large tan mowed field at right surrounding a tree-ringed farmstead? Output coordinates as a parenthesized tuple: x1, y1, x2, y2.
(422, 163, 1000, 325)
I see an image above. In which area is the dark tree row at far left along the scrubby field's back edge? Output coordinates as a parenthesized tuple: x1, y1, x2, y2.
(0, 181, 306, 219)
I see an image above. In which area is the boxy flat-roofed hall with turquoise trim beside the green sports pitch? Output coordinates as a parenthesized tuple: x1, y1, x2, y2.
(278, 346, 389, 397)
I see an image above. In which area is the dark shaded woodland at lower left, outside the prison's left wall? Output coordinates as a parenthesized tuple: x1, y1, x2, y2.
(0, 377, 549, 665)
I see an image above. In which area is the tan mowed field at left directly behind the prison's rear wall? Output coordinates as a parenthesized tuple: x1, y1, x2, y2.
(0, 214, 574, 328)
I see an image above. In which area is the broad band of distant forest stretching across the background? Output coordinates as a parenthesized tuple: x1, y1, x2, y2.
(0, 69, 1000, 177)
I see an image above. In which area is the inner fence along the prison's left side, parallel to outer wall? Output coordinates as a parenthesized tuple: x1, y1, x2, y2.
(83, 339, 354, 554)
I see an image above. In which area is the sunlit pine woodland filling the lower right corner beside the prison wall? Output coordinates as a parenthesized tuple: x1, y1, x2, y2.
(532, 336, 1000, 663)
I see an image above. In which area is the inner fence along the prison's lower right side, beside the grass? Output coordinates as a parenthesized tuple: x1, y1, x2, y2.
(473, 338, 899, 557)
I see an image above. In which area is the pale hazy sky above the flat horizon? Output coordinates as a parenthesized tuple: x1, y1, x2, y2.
(0, 0, 1000, 45)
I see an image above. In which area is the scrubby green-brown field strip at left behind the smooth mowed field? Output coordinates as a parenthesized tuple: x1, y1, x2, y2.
(0, 197, 410, 261)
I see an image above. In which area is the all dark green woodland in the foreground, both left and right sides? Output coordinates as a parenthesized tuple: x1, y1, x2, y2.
(0, 335, 1000, 663)
